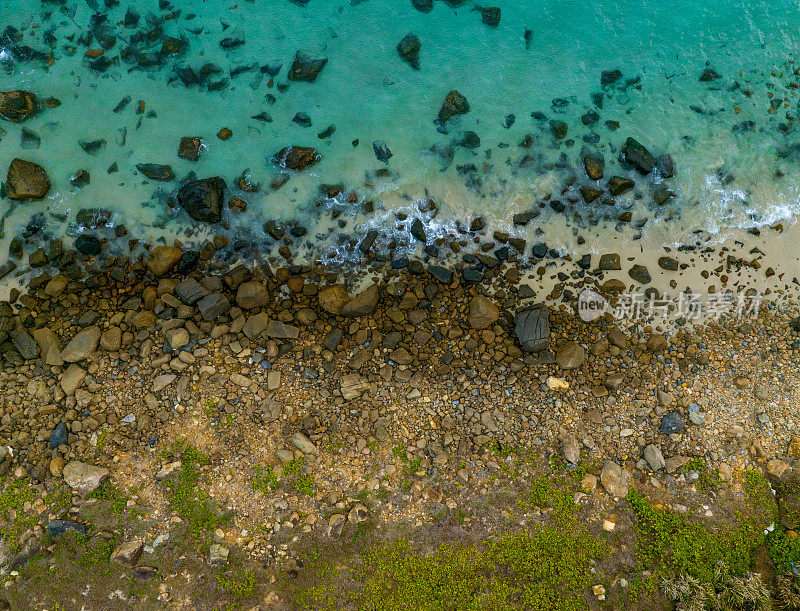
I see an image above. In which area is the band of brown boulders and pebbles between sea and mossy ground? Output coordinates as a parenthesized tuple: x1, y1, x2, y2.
(0, 233, 800, 608)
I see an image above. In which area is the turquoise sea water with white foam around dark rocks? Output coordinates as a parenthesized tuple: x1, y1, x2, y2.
(0, 0, 800, 266)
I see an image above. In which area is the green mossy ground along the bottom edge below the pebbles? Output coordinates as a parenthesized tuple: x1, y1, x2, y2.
(0, 443, 800, 611)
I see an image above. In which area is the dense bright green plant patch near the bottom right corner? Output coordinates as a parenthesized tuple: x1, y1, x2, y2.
(627, 490, 768, 583)
